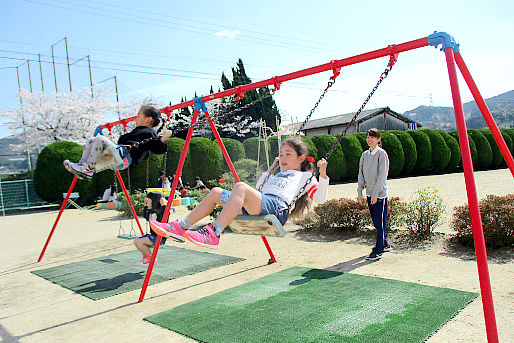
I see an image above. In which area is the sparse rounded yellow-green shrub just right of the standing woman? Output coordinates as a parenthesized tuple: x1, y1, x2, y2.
(403, 187, 445, 239)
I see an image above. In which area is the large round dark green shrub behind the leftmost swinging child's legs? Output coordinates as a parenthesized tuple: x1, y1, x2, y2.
(34, 141, 98, 204)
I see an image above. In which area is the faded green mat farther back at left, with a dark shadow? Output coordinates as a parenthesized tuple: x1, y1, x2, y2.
(32, 246, 244, 300)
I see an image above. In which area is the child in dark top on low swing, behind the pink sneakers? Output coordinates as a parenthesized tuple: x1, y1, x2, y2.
(134, 192, 166, 266)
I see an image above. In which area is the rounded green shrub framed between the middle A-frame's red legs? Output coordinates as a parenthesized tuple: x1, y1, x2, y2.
(182, 137, 221, 185)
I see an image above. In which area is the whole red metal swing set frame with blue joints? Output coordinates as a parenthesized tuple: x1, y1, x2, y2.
(38, 32, 508, 342)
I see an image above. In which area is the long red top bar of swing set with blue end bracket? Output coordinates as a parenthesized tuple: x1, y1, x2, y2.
(95, 32, 459, 135)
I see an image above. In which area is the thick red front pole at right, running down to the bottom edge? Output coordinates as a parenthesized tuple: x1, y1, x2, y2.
(444, 47, 498, 343)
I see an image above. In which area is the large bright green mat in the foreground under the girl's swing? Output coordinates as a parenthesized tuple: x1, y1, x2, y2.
(145, 267, 477, 343)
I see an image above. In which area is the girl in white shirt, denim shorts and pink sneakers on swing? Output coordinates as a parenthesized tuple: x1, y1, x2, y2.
(150, 138, 329, 249)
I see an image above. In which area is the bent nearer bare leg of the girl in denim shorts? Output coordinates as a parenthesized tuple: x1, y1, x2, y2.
(214, 182, 262, 227)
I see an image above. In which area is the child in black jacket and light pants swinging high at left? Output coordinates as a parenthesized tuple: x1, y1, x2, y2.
(63, 106, 172, 179)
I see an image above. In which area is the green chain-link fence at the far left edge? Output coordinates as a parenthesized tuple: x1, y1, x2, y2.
(0, 179, 49, 213)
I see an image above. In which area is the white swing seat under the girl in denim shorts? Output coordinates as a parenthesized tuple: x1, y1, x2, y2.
(230, 214, 286, 237)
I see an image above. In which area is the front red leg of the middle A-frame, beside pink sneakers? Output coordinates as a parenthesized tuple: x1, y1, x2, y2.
(138, 110, 198, 302)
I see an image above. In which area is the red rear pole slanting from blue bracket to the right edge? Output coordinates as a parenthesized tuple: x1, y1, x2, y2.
(455, 52, 514, 177)
